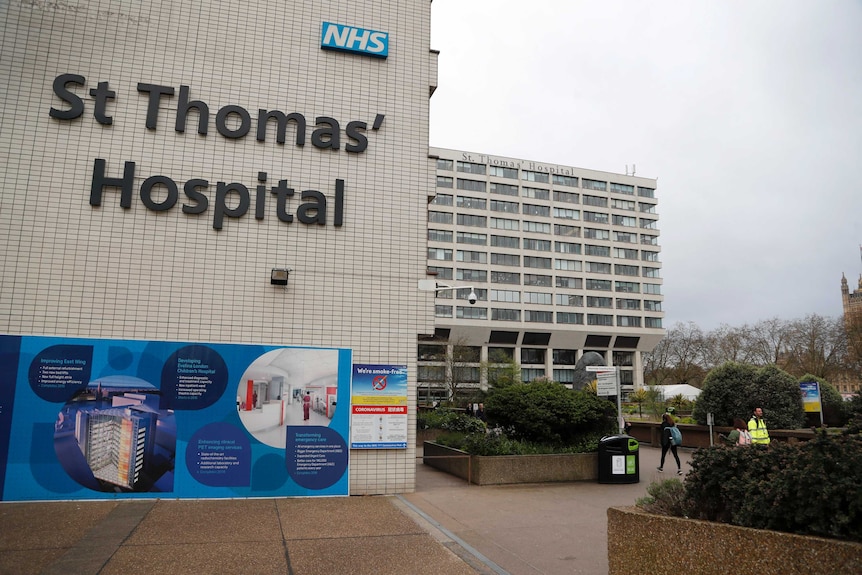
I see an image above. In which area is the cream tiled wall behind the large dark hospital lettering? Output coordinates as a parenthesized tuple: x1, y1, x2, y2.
(0, 0, 436, 494)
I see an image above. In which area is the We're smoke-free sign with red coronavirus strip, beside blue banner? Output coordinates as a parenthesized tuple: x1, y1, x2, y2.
(350, 364, 407, 449)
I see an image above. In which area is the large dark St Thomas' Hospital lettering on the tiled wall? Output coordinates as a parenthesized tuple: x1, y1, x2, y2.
(49, 74, 385, 230)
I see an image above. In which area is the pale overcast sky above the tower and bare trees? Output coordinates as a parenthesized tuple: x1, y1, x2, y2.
(430, 0, 862, 330)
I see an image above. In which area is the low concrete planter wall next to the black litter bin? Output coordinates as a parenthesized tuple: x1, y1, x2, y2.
(422, 441, 598, 485)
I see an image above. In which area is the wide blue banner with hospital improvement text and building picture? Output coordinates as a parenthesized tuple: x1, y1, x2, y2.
(0, 335, 352, 501)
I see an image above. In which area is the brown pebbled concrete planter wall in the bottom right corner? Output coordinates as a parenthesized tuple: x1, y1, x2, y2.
(608, 507, 862, 575)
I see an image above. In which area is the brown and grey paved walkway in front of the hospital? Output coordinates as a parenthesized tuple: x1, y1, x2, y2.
(0, 446, 688, 575)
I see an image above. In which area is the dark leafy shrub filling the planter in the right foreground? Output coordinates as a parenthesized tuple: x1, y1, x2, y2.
(685, 432, 862, 541)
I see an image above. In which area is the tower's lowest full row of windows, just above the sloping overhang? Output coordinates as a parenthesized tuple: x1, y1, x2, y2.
(434, 305, 661, 328)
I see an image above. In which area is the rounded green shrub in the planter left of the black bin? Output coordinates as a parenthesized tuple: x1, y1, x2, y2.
(485, 381, 617, 446)
